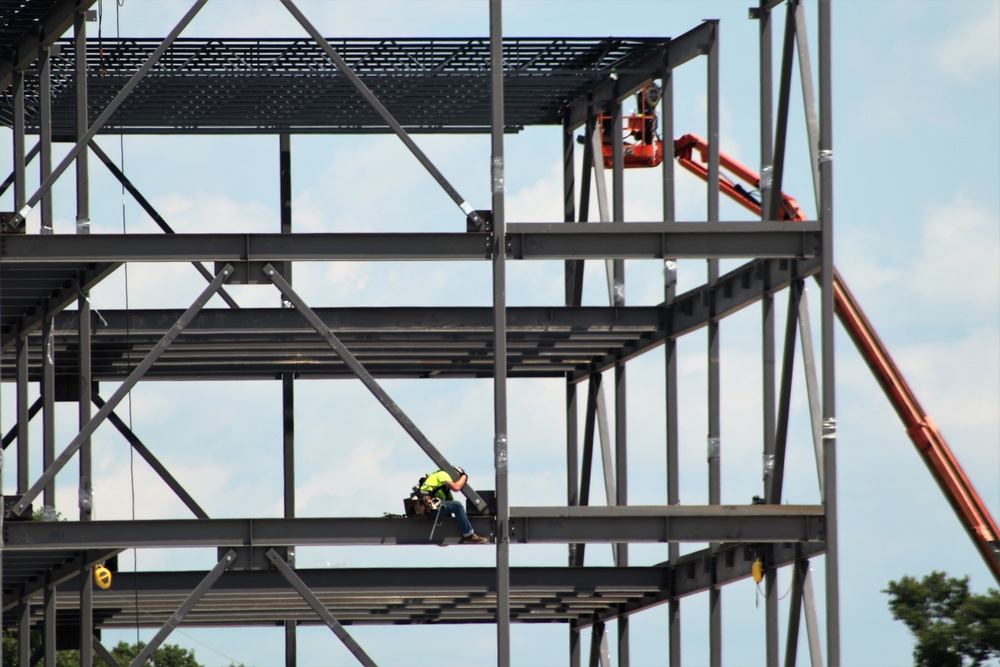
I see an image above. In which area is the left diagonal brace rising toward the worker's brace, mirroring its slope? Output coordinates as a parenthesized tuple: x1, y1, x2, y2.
(10, 264, 233, 516)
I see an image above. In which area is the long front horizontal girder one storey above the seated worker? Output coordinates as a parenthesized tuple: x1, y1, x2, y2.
(0, 227, 820, 266)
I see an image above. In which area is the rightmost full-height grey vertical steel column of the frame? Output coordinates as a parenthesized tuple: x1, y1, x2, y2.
(819, 0, 840, 667)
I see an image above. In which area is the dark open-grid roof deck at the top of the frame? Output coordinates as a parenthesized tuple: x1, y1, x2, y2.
(0, 38, 666, 140)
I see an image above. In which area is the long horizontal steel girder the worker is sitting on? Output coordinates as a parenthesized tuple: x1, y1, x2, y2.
(4, 505, 825, 552)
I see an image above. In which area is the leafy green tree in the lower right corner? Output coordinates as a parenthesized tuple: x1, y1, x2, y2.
(882, 572, 1000, 667)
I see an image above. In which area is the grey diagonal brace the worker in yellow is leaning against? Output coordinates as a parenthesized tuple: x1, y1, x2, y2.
(262, 264, 486, 511)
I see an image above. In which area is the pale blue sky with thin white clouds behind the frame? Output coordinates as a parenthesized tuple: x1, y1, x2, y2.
(0, 0, 1000, 665)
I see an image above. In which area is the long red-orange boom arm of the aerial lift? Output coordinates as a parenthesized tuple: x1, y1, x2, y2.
(674, 134, 1000, 581)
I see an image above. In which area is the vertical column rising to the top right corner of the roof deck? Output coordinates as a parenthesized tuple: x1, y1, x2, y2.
(708, 21, 722, 665)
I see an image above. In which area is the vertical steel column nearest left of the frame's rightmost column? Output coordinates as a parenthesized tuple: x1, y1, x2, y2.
(757, 0, 779, 667)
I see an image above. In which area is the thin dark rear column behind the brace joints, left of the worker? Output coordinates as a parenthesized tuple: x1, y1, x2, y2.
(278, 132, 298, 667)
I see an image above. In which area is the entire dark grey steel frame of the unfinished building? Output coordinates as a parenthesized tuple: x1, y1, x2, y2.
(0, 0, 840, 665)
